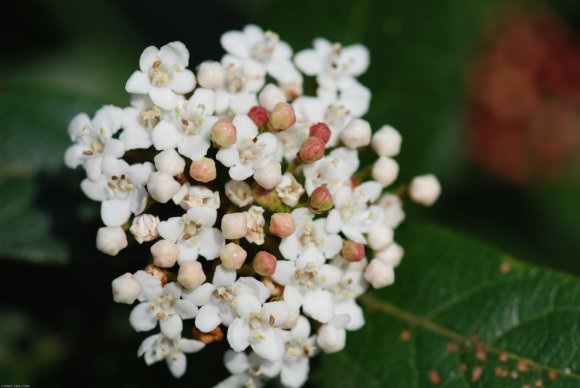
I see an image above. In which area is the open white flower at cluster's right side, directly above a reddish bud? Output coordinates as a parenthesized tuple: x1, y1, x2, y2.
(326, 181, 384, 244)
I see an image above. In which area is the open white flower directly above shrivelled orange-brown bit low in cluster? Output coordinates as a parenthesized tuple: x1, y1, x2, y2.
(183, 265, 270, 333)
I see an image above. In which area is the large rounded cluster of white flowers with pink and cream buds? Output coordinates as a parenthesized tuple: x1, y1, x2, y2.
(65, 25, 440, 387)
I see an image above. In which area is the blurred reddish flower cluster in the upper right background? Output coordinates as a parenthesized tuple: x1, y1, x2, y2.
(469, 10, 580, 183)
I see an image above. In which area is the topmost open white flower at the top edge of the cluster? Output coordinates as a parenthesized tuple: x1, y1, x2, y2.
(221, 25, 302, 84)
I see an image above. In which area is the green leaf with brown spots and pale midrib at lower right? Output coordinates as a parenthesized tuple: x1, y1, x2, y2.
(314, 225, 580, 387)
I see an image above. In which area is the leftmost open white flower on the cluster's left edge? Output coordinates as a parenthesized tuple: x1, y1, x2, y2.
(64, 105, 125, 181)
